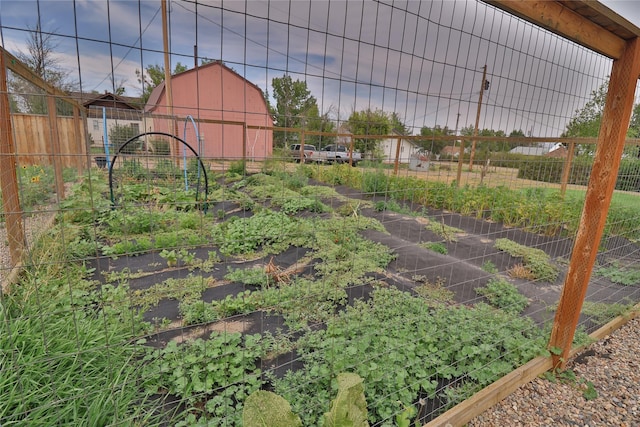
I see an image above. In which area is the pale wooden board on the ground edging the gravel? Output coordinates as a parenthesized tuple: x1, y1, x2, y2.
(423, 304, 640, 427)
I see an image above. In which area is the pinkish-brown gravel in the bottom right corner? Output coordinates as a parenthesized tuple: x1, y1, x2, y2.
(468, 318, 640, 427)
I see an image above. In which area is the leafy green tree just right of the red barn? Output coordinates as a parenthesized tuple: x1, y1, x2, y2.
(270, 75, 320, 146)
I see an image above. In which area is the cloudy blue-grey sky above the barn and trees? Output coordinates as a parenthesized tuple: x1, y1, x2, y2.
(0, 0, 640, 136)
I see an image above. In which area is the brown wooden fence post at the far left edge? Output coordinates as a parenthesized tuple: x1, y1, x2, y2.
(0, 51, 25, 266)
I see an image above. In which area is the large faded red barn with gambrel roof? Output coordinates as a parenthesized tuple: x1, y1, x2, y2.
(144, 61, 273, 159)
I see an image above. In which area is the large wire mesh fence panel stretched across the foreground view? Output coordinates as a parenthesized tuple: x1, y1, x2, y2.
(0, 0, 640, 426)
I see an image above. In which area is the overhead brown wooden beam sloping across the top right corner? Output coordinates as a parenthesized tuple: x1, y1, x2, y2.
(484, 0, 624, 59)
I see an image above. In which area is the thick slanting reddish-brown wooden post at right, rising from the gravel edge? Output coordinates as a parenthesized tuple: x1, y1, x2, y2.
(549, 38, 640, 367)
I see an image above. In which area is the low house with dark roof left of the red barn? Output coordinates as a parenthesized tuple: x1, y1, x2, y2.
(71, 91, 145, 146)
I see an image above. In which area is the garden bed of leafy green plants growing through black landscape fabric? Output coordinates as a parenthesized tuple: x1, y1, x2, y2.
(2, 162, 640, 426)
